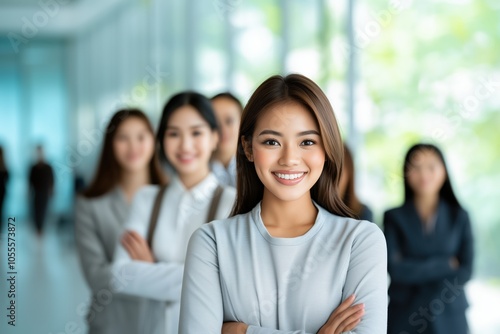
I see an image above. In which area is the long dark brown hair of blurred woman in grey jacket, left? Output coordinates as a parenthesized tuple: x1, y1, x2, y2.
(83, 109, 166, 198)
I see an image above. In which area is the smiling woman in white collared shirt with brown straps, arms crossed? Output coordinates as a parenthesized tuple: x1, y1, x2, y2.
(114, 92, 235, 334)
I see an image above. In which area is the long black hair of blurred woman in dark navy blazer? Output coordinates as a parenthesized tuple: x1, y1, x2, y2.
(403, 143, 462, 208)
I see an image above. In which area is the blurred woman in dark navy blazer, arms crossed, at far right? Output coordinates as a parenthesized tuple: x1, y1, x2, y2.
(384, 144, 473, 334)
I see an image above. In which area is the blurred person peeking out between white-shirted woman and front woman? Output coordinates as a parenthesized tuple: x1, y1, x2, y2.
(211, 92, 243, 187)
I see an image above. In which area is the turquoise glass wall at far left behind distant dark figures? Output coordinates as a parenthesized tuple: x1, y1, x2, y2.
(0, 39, 73, 217)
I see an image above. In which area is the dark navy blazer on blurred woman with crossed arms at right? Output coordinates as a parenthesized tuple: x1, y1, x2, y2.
(384, 200, 473, 334)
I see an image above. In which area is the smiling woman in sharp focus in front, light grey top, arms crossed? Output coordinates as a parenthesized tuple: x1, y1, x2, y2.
(179, 74, 387, 334)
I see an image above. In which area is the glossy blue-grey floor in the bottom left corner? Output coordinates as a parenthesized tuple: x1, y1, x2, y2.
(0, 221, 90, 334)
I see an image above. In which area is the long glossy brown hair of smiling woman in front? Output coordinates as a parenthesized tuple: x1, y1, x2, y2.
(231, 74, 352, 217)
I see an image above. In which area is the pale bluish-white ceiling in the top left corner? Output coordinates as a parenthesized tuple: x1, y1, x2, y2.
(0, 0, 128, 38)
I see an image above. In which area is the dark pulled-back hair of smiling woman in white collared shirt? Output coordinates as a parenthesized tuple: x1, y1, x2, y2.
(156, 91, 218, 163)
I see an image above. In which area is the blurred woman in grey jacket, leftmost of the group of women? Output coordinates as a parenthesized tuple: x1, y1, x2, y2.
(75, 109, 166, 334)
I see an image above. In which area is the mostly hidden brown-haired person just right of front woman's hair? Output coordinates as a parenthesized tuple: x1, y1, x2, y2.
(339, 143, 373, 222)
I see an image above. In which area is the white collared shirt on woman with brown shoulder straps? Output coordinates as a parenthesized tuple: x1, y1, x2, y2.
(113, 173, 236, 334)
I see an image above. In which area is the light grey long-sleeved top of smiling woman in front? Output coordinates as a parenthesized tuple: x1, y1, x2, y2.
(179, 203, 387, 334)
